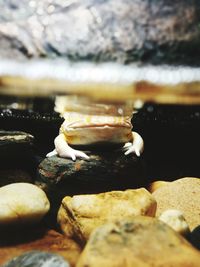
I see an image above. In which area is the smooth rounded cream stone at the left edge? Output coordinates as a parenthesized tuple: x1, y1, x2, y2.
(0, 183, 50, 225)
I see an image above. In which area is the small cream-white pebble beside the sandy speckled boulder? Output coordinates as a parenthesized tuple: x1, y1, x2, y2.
(159, 209, 190, 235)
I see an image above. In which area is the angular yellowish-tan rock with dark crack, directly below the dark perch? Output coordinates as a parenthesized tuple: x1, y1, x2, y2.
(57, 188, 156, 242)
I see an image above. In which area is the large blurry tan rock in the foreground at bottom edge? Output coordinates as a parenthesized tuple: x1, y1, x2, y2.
(76, 216, 200, 267)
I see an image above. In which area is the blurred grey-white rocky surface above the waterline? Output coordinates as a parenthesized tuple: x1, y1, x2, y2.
(0, 0, 200, 64)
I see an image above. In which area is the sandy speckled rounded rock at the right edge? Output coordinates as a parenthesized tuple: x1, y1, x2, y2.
(153, 177, 200, 230)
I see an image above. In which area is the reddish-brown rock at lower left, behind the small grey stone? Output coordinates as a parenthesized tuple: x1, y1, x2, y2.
(0, 227, 81, 267)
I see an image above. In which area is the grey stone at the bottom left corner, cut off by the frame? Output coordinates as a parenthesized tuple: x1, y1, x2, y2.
(3, 251, 70, 267)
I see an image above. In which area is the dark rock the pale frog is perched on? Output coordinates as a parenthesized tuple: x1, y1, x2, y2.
(36, 149, 147, 214)
